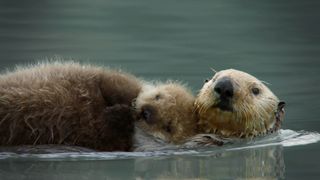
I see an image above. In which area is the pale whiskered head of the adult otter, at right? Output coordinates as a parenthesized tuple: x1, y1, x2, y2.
(195, 69, 284, 137)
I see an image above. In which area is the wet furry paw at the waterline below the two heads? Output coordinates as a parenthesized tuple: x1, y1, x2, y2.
(183, 134, 231, 148)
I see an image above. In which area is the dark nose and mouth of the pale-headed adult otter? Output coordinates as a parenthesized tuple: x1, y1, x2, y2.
(213, 77, 234, 111)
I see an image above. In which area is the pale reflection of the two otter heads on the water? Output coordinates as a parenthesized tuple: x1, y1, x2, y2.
(135, 146, 285, 179)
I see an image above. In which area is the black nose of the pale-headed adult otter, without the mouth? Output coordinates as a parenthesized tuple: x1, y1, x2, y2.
(214, 78, 233, 99)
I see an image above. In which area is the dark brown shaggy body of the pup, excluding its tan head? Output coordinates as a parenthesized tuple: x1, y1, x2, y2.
(0, 62, 142, 151)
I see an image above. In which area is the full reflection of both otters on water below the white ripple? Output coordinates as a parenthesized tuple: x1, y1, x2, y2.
(0, 145, 285, 180)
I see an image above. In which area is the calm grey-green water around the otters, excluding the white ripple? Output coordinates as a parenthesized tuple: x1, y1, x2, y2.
(0, 0, 320, 179)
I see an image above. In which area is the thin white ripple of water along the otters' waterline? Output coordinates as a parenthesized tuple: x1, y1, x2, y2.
(0, 129, 320, 161)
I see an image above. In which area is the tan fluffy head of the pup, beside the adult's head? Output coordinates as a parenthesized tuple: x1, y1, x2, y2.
(134, 82, 197, 143)
